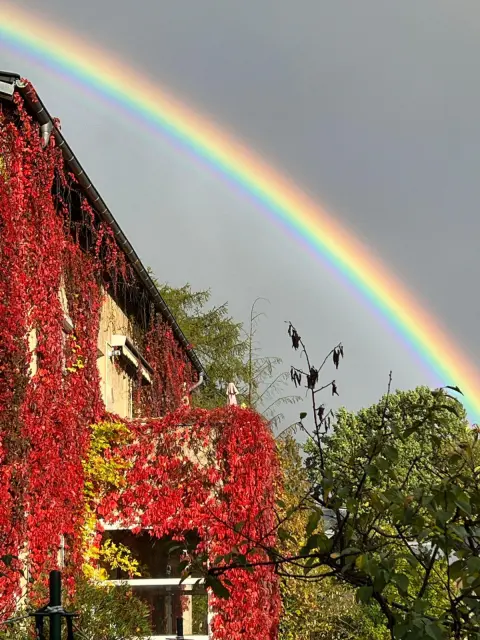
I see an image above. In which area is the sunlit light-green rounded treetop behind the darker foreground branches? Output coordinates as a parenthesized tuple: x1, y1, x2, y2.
(314, 387, 468, 489)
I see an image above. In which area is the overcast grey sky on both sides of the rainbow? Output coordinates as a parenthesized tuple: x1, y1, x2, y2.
(0, 0, 480, 430)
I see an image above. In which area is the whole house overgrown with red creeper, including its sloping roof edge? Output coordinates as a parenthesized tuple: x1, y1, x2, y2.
(0, 72, 278, 640)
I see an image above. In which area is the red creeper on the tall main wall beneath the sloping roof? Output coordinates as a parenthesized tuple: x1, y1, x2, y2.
(0, 89, 191, 608)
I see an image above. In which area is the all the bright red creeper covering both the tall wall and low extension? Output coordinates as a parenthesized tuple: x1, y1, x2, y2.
(0, 87, 279, 640)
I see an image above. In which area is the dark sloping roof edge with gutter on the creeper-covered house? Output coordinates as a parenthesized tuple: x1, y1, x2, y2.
(0, 71, 206, 377)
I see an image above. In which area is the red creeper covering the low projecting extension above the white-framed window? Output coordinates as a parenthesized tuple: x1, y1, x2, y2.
(98, 407, 280, 640)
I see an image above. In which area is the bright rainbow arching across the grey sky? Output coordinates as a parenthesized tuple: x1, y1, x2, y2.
(0, 0, 480, 419)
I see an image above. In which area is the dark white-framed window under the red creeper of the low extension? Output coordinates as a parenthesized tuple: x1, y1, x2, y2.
(104, 529, 209, 640)
